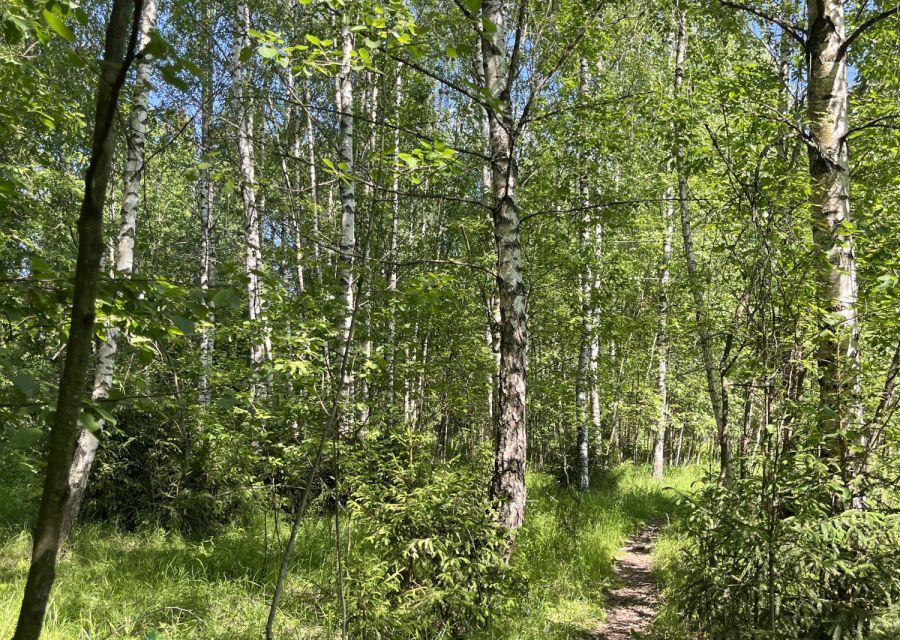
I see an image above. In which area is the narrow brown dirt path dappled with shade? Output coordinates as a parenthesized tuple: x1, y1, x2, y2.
(594, 522, 662, 640)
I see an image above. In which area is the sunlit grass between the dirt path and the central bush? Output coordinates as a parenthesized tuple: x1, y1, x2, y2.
(481, 464, 700, 640)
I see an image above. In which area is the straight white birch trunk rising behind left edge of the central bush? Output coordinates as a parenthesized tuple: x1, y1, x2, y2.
(335, 22, 356, 433)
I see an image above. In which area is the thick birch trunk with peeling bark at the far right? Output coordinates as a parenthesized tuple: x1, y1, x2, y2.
(807, 0, 867, 508)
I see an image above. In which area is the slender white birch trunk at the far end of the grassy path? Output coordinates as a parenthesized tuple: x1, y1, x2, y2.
(653, 188, 675, 478)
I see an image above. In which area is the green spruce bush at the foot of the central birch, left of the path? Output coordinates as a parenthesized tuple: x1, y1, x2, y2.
(346, 431, 519, 639)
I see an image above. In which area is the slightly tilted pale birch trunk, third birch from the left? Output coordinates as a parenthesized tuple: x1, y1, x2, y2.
(231, 0, 272, 398)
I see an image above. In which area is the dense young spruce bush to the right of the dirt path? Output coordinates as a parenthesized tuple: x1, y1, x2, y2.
(669, 456, 900, 640)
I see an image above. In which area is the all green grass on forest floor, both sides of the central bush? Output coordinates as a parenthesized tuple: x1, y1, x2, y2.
(0, 466, 698, 640)
